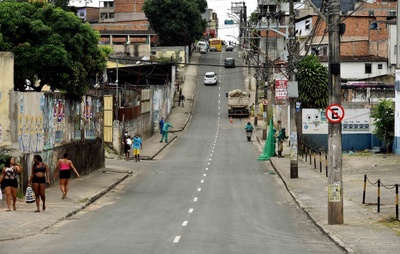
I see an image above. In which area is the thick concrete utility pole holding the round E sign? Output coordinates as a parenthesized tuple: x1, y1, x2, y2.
(327, 0, 343, 225)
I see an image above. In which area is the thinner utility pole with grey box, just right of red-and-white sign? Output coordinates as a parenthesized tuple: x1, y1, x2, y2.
(288, 0, 299, 178)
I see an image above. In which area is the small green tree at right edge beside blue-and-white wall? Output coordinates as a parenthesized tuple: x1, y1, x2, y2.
(371, 99, 394, 152)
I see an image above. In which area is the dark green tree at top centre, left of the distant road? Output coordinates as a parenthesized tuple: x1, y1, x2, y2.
(143, 0, 207, 46)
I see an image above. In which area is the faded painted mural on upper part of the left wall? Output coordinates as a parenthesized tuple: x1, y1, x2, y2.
(18, 93, 103, 153)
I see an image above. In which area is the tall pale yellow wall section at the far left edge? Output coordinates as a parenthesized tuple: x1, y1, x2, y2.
(0, 52, 14, 149)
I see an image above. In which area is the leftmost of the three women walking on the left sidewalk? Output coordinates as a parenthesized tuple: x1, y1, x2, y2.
(0, 157, 22, 212)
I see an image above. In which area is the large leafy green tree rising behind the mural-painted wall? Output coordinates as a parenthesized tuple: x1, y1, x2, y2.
(0, 1, 110, 100)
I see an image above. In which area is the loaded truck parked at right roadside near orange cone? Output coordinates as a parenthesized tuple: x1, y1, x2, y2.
(226, 89, 250, 117)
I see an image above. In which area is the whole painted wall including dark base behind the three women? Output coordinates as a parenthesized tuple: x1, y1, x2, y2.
(7, 91, 105, 189)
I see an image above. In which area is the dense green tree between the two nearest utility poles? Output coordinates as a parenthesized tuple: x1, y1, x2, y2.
(297, 55, 329, 109)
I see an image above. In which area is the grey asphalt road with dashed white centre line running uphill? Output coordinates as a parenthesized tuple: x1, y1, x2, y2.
(1, 52, 342, 254)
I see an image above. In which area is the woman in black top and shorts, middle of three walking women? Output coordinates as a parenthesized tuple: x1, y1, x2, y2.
(28, 155, 50, 212)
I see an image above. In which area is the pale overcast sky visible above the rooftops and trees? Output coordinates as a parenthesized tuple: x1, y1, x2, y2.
(70, 0, 257, 41)
